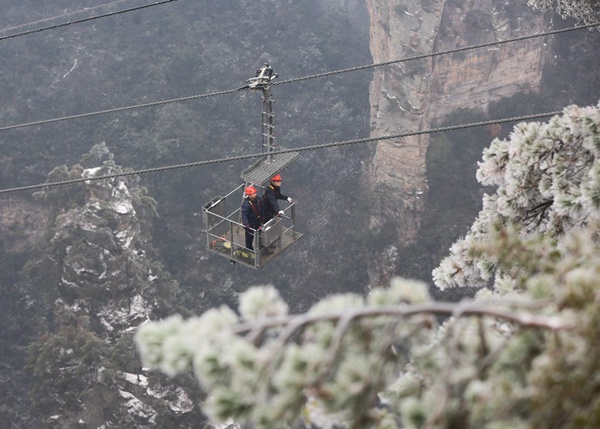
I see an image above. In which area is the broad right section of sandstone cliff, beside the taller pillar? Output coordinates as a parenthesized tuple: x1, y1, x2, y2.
(431, 0, 549, 118)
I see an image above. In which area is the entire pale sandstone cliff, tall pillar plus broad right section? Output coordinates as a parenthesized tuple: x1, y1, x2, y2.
(363, 0, 549, 283)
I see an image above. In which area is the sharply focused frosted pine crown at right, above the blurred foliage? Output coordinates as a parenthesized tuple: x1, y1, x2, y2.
(433, 106, 600, 289)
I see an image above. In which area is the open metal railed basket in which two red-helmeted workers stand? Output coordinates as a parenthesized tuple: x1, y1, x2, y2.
(202, 183, 302, 269)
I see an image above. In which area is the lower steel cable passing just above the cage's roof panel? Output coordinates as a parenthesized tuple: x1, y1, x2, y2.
(0, 111, 561, 194)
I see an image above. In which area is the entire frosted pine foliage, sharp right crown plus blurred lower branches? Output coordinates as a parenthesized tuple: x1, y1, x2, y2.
(136, 106, 600, 429)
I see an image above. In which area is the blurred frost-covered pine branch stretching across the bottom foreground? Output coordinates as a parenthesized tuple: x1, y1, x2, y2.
(136, 279, 572, 428)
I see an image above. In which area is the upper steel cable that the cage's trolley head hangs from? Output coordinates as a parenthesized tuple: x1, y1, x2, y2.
(0, 21, 600, 131)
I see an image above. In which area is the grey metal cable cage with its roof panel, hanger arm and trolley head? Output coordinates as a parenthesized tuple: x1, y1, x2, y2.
(202, 64, 302, 269)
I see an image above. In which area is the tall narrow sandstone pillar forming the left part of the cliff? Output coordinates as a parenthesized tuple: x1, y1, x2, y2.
(366, 0, 443, 240)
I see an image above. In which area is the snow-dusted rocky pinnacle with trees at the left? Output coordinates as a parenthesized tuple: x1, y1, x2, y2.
(22, 143, 200, 428)
